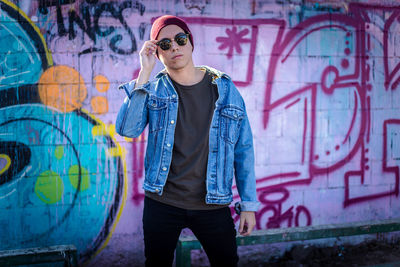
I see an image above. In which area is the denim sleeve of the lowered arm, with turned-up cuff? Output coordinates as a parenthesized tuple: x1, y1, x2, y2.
(234, 101, 259, 214)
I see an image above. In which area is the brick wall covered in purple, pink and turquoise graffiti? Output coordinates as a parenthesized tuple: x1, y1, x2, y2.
(0, 0, 400, 266)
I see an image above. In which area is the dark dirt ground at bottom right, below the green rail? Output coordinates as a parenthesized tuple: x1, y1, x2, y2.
(263, 240, 400, 267)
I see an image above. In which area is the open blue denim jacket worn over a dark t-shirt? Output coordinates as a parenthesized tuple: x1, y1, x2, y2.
(116, 66, 259, 211)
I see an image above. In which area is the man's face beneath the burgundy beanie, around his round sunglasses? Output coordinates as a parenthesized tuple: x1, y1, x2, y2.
(157, 25, 193, 70)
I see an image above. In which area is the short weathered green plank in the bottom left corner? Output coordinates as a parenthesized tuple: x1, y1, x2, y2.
(0, 245, 77, 266)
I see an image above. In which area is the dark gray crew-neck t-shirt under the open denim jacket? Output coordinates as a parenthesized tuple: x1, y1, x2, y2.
(146, 72, 227, 210)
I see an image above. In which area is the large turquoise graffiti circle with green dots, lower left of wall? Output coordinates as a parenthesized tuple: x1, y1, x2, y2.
(0, 104, 124, 262)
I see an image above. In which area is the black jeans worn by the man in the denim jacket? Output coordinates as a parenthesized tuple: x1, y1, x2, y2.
(143, 197, 239, 267)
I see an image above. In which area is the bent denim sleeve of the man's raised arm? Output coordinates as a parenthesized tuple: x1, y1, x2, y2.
(115, 80, 150, 137)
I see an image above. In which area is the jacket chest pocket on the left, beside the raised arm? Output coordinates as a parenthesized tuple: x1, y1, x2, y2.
(147, 96, 168, 132)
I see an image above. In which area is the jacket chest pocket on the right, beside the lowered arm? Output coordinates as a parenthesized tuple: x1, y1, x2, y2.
(220, 107, 244, 144)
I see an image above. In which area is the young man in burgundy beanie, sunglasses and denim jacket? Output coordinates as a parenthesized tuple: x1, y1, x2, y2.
(116, 15, 258, 266)
